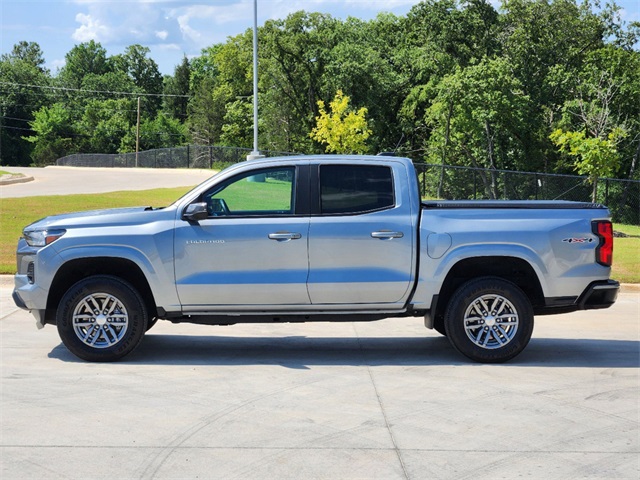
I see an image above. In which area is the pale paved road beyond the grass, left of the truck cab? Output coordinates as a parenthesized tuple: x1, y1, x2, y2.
(0, 167, 213, 198)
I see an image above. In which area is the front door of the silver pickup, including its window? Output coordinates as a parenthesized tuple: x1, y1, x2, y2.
(175, 166, 310, 311)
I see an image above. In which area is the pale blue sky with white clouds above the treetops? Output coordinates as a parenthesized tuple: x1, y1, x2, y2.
(0, 0, 640, 74)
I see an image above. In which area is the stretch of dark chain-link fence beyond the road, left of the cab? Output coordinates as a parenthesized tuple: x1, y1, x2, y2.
(56, 145, 293, 170)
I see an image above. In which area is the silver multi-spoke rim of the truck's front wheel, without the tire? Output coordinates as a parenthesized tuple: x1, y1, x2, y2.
(73, 293, 129, 348)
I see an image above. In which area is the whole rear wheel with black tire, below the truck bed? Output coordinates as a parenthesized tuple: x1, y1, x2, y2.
(444, 277, 533, 363)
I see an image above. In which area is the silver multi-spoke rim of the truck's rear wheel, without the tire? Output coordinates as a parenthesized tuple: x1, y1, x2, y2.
(464, 294, 519, 350)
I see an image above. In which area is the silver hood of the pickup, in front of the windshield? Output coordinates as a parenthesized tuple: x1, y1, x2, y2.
(24, 207, 173, 231)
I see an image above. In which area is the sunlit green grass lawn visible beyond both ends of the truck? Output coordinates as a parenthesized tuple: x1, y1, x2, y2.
(0, 185, 640, 283)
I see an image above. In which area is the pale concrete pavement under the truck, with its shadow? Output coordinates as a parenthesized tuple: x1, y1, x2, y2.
(0, 284, 640, 480)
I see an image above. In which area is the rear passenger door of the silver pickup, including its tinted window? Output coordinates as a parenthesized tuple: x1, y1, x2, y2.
(308, 163, 415, 308)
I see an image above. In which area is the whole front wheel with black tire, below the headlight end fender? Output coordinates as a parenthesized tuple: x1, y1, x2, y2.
(56, 275, 148, 362)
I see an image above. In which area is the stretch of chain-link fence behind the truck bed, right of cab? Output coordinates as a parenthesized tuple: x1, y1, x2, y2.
(415, 163, 640, 225)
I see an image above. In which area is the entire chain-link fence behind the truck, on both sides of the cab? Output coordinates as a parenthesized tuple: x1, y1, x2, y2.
(56, 145, 640, 225)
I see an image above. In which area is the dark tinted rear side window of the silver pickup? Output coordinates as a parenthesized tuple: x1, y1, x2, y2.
(320, 165, 395, 214)
